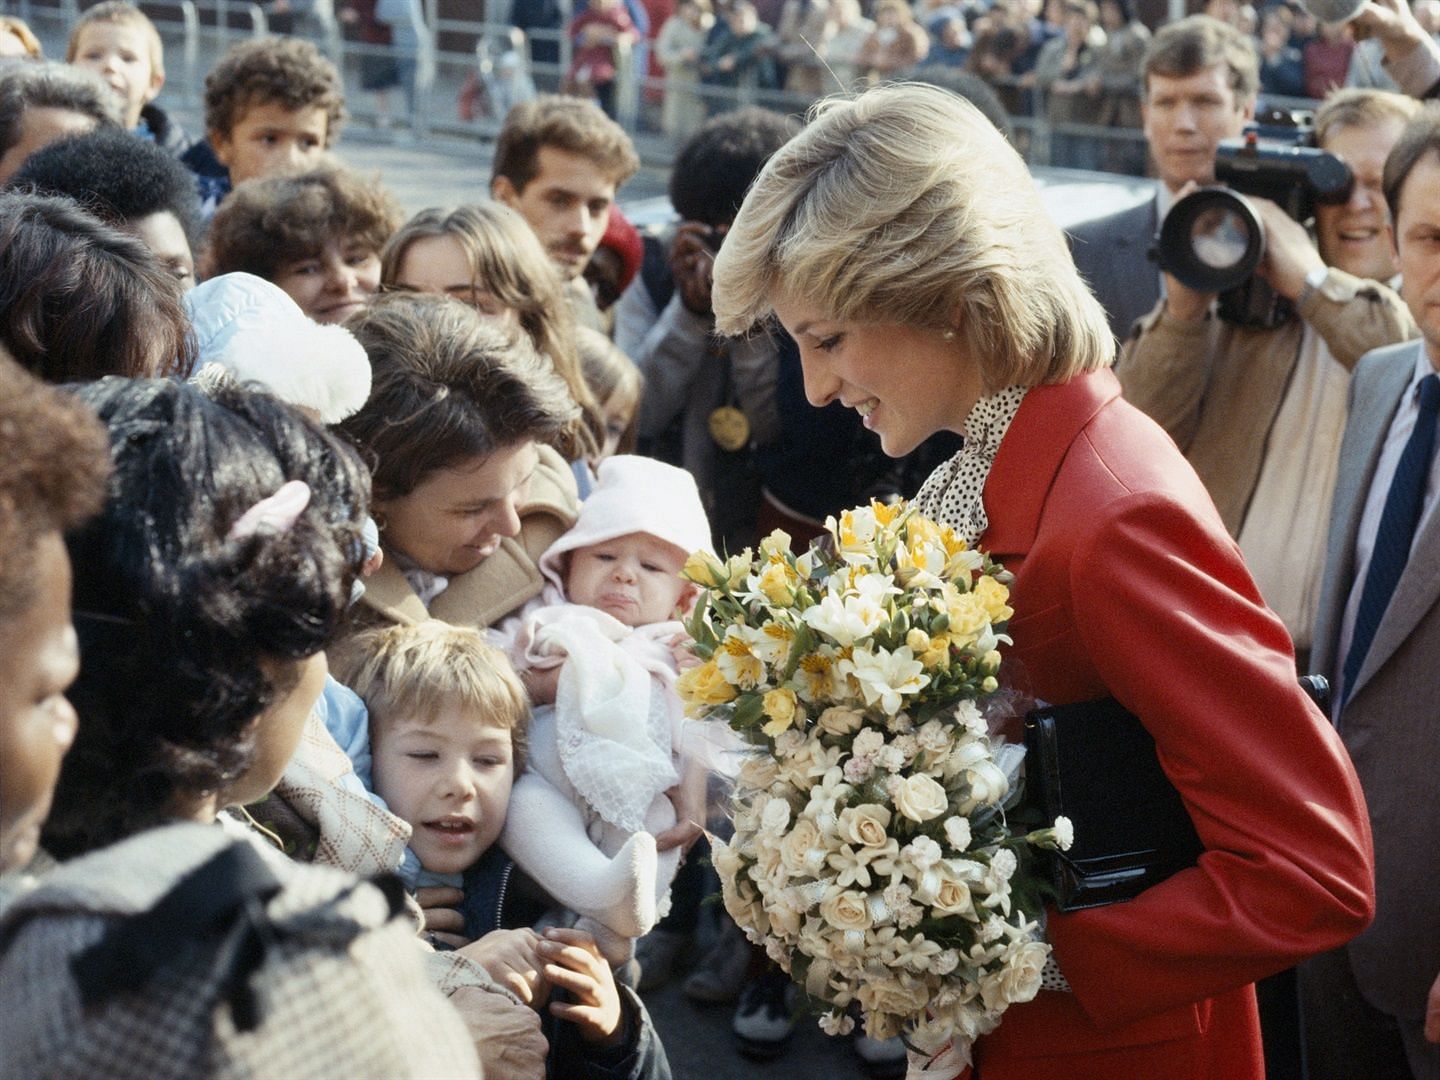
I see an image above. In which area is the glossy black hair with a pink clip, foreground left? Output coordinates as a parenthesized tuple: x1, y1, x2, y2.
(43, 379, 369, 858)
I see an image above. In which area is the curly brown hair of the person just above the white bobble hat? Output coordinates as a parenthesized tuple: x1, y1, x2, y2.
(206, 161, 405, 281)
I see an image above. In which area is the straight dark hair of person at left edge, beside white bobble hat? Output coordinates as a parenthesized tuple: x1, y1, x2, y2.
(0, 188, 194, 383)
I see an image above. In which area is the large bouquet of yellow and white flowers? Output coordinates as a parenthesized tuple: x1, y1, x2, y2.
(680, 503, 1070, 1064)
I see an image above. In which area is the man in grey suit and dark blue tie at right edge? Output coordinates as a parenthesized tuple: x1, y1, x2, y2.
(1300, 109, 1440, 1080)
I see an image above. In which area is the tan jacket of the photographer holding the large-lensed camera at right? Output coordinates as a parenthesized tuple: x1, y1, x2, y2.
(1116, 269, 1418, 536)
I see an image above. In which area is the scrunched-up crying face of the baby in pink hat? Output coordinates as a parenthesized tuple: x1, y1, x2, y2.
(564, 533, 690, 626)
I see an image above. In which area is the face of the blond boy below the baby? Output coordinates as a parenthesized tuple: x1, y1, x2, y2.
(372, 701, 516, 874)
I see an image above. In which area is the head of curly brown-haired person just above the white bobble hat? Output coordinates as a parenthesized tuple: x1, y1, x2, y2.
(206, 163, 402, 323)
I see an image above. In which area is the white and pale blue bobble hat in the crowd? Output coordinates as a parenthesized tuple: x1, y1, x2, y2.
(184, 274, 370, 423)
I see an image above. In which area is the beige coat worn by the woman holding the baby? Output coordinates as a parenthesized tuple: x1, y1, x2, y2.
(356, 446, 580, 628)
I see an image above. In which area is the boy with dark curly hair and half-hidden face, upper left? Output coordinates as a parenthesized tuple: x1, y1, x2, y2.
(181, 37, 346, 216)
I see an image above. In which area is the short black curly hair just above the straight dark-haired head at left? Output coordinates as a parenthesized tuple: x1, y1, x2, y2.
(7, 130, 200, 248)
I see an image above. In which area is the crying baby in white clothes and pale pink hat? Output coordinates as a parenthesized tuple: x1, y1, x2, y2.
(495, 456, 723, 963)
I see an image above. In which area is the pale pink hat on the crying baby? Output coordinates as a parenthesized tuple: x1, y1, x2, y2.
(540, 454, 711, 588)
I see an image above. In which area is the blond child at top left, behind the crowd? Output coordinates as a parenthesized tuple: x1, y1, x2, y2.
(65, 0, 192, 157)
